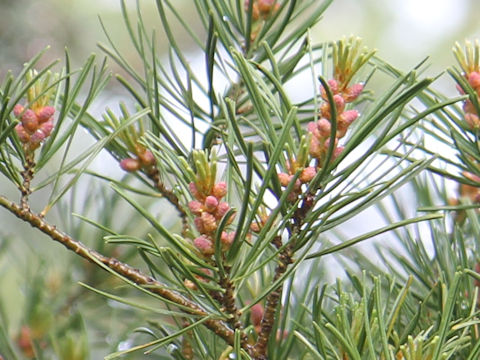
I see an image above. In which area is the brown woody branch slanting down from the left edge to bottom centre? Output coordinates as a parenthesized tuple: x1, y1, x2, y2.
(0, 196, 240, 350)
